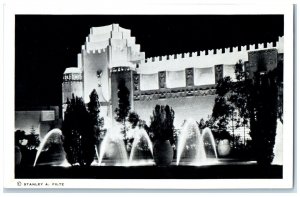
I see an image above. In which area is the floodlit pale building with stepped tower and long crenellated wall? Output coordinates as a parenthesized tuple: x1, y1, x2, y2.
(62, 24, 283, 131)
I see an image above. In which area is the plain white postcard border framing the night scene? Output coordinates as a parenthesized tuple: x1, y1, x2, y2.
(4, 2, 294, 189)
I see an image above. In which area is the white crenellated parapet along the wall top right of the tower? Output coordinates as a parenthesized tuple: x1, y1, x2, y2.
(137, 37, 283, 74)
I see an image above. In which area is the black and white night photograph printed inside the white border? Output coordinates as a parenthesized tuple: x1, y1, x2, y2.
(1, 1, 293, 188)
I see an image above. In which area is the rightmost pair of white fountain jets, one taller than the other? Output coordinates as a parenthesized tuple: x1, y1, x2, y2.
(176, 119, 217, 166)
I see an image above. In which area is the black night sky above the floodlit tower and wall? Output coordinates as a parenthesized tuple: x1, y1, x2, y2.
(15, 15, 283, 109)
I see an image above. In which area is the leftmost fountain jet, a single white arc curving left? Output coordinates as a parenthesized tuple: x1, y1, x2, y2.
(33, 129, 65, 166)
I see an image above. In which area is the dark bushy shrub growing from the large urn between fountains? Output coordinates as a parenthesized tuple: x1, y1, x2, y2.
(149, 105, 175, 144)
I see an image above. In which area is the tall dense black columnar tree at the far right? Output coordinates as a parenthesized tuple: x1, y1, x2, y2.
(248, 66, 278, 165)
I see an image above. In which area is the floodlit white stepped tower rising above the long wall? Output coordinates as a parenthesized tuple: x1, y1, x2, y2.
(62, 24, 145, 126)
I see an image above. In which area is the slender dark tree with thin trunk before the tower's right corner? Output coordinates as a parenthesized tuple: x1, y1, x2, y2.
(115, 79, 130, 139)
